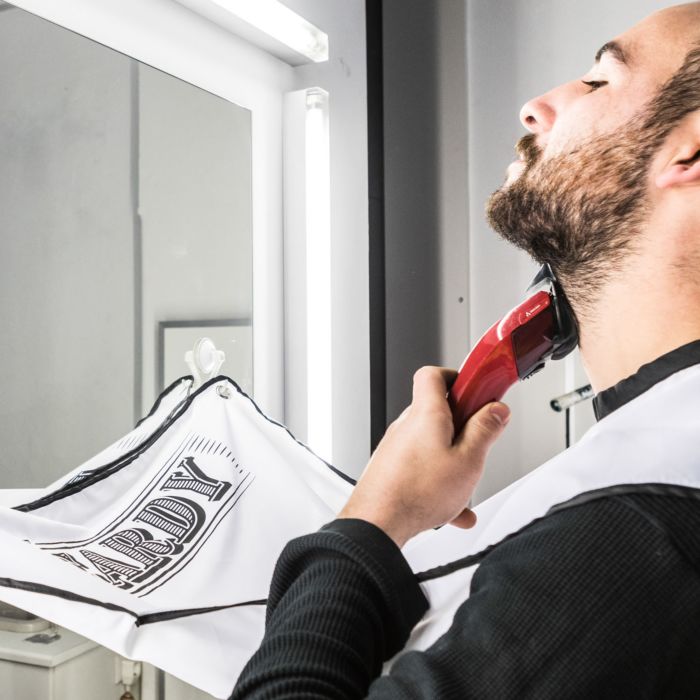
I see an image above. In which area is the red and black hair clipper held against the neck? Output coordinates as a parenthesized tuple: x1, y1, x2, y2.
(447, 265, 578, 435)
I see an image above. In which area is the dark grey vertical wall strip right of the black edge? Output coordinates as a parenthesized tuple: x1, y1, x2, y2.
(383, 0, 468, 421)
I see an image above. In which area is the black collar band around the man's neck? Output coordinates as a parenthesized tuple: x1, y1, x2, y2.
(593, 340, 700, 420)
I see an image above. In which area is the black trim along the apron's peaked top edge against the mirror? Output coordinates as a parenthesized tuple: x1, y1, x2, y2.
(14, 375, 356, 513)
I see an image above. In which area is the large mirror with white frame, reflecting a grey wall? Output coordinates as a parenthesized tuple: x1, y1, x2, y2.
(0, 4, 253, 488)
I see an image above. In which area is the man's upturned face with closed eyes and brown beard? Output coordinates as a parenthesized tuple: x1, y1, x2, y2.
(488, 3, 700, 307)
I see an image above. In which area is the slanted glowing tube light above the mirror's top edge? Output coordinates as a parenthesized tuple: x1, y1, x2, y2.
(177, 0, 328, 65)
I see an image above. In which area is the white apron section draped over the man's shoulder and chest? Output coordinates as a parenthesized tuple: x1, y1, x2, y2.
(390, 365, 700, 663)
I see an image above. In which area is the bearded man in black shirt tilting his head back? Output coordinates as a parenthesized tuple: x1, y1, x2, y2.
(232, 3, 700, 700)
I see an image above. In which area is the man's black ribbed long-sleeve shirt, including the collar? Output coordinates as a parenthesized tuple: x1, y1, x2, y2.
(232, 341, 700, 700)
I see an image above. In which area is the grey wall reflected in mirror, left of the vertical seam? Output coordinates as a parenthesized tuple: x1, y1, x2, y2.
(0, 10, 134, 488)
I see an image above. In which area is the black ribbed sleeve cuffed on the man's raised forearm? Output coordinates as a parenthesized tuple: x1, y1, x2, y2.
(232, 520, 427, 700)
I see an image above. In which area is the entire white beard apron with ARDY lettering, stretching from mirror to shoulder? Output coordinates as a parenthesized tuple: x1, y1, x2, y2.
(0, 366, 700, 698)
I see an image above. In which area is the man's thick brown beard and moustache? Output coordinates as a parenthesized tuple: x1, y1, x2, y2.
(487, 118, 656, 316)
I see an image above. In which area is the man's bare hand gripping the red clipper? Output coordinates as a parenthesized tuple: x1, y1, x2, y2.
(338, 367, 510, 547)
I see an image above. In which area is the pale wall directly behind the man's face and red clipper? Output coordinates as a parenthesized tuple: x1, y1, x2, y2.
(466, 0, 675, 500)
